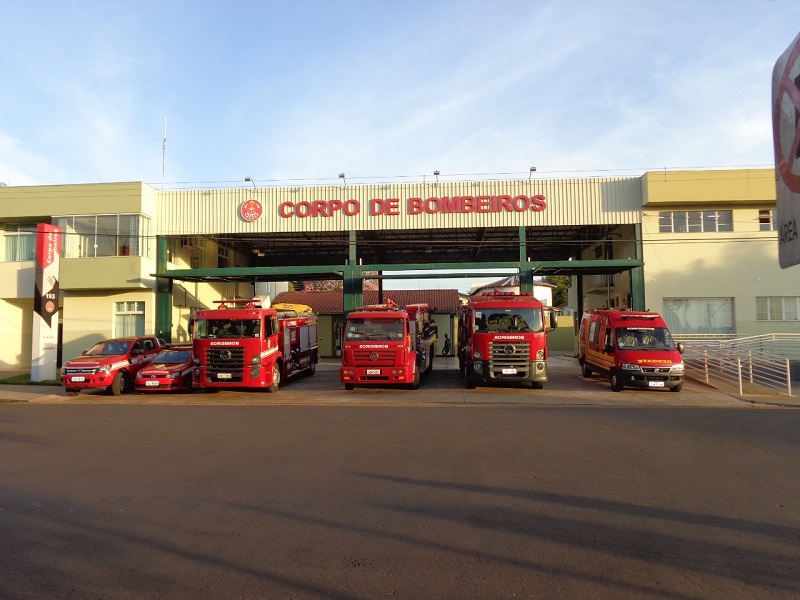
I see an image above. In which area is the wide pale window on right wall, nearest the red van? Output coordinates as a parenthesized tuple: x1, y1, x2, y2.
(663, 298, 735, 335)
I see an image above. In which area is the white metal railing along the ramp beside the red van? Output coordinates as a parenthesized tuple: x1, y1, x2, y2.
(680, 334, 800, 397)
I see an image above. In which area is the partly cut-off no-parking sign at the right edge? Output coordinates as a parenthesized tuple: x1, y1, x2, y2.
(772, 29, 800, 269)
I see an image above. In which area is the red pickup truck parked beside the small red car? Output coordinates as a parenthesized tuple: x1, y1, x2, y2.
(61, 336, 165, 396)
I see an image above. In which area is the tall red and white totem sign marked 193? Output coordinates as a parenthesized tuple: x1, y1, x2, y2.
(31, 223, 61, 381)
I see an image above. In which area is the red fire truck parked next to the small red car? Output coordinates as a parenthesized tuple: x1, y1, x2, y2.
(192, 297, 319, 392)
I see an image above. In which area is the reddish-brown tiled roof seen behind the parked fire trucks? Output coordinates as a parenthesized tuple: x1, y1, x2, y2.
(272, 290, 460, 315)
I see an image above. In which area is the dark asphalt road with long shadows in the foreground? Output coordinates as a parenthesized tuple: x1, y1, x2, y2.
(0, 396, 800, 600)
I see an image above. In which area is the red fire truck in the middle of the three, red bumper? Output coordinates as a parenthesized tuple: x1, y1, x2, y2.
(340, 301, 437, 390)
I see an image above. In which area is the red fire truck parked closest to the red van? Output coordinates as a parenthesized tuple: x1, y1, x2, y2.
(458, 292, 558, 389)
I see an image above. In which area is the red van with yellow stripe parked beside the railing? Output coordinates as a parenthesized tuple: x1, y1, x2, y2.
(578, 309, 683, 392)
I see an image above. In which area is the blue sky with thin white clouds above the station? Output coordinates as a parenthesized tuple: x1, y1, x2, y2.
(0, 0, 800, 290)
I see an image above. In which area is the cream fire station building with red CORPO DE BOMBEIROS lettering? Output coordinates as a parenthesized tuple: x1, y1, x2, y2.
(0, 169, 800, 370)
